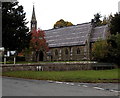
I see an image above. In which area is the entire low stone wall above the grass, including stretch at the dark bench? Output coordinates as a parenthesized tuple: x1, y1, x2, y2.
(2, 62, 116, 72)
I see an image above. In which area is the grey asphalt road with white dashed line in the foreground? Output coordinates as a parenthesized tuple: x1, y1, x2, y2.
(2, 77, 119, 96)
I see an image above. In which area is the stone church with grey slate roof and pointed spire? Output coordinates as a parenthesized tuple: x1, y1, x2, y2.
(31, 6, 108, 61)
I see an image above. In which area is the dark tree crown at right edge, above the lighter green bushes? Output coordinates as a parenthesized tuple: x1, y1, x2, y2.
(110, 13, 120, 34)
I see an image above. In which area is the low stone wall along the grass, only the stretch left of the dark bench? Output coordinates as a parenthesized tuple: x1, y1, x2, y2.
(2, 62, 92, 72)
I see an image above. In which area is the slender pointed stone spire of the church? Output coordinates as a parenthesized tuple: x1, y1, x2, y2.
(31, 5, 37, 31)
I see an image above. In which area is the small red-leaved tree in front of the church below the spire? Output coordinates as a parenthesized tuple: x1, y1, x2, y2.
(30, 29, 49, 61)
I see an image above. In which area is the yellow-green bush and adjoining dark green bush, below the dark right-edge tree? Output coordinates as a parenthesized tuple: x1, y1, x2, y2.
(92, 34, 120, 65)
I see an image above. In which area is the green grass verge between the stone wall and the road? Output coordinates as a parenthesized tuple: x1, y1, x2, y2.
(2, 69, 120, 83)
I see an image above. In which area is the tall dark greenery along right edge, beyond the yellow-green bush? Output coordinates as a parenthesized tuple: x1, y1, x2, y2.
(108, 13, 120, 65)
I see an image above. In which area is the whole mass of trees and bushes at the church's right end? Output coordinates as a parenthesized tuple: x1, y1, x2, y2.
(93, 13, 120, 65)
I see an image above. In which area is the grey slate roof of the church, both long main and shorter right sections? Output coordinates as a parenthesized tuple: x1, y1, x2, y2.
(45, 23, 107, 48)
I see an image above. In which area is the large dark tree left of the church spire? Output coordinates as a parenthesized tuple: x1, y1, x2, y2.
(2, 2, 31, 52)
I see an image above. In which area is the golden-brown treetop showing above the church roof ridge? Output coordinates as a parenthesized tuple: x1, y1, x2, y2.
(54, 19, 73, 29)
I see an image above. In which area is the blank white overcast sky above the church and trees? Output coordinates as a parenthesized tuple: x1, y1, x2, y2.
(18, 0, 120, 30)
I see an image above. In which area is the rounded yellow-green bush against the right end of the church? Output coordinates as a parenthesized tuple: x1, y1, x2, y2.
(92, 40, 109, 61)
